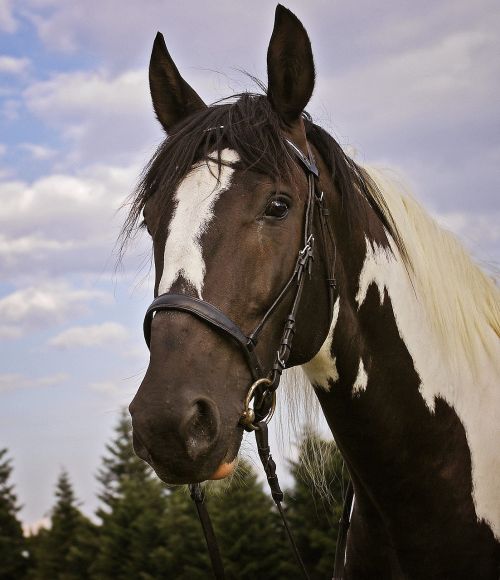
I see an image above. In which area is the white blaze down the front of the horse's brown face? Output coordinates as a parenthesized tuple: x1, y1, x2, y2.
(158, 149, 239, 299)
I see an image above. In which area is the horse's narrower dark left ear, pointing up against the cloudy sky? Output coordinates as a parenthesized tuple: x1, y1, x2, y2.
(149, 32, 206, 133)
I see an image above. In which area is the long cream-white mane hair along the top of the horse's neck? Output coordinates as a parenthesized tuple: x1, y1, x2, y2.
(365, 167, 500, 371)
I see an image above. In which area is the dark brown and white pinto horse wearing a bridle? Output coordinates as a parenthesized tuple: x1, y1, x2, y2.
(124, 5, 500, 579)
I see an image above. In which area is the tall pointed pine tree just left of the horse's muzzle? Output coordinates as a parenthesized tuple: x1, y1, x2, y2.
(91, 411, 174, 580)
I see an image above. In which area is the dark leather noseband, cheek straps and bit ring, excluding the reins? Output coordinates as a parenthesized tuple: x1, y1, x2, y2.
(144, 139, 335, 431)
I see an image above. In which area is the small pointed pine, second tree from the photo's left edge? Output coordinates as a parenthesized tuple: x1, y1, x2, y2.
(31, 471, 97, 580)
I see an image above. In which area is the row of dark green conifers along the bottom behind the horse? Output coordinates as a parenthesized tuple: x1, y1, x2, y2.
(0, 412, 347, 580)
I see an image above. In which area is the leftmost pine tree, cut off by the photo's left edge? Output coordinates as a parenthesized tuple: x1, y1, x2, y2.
(0, 449, 28, 580)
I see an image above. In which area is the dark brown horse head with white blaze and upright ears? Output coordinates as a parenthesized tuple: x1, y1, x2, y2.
(130, 7, 334, 483)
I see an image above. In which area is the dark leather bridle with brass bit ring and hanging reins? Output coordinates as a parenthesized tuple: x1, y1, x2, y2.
(144, 139, 347, 579)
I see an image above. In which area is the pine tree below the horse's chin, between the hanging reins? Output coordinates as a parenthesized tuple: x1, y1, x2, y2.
(209, 460, 296, 580)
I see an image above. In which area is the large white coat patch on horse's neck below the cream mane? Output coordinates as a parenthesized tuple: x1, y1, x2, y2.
(356, 234, 500, 540)
